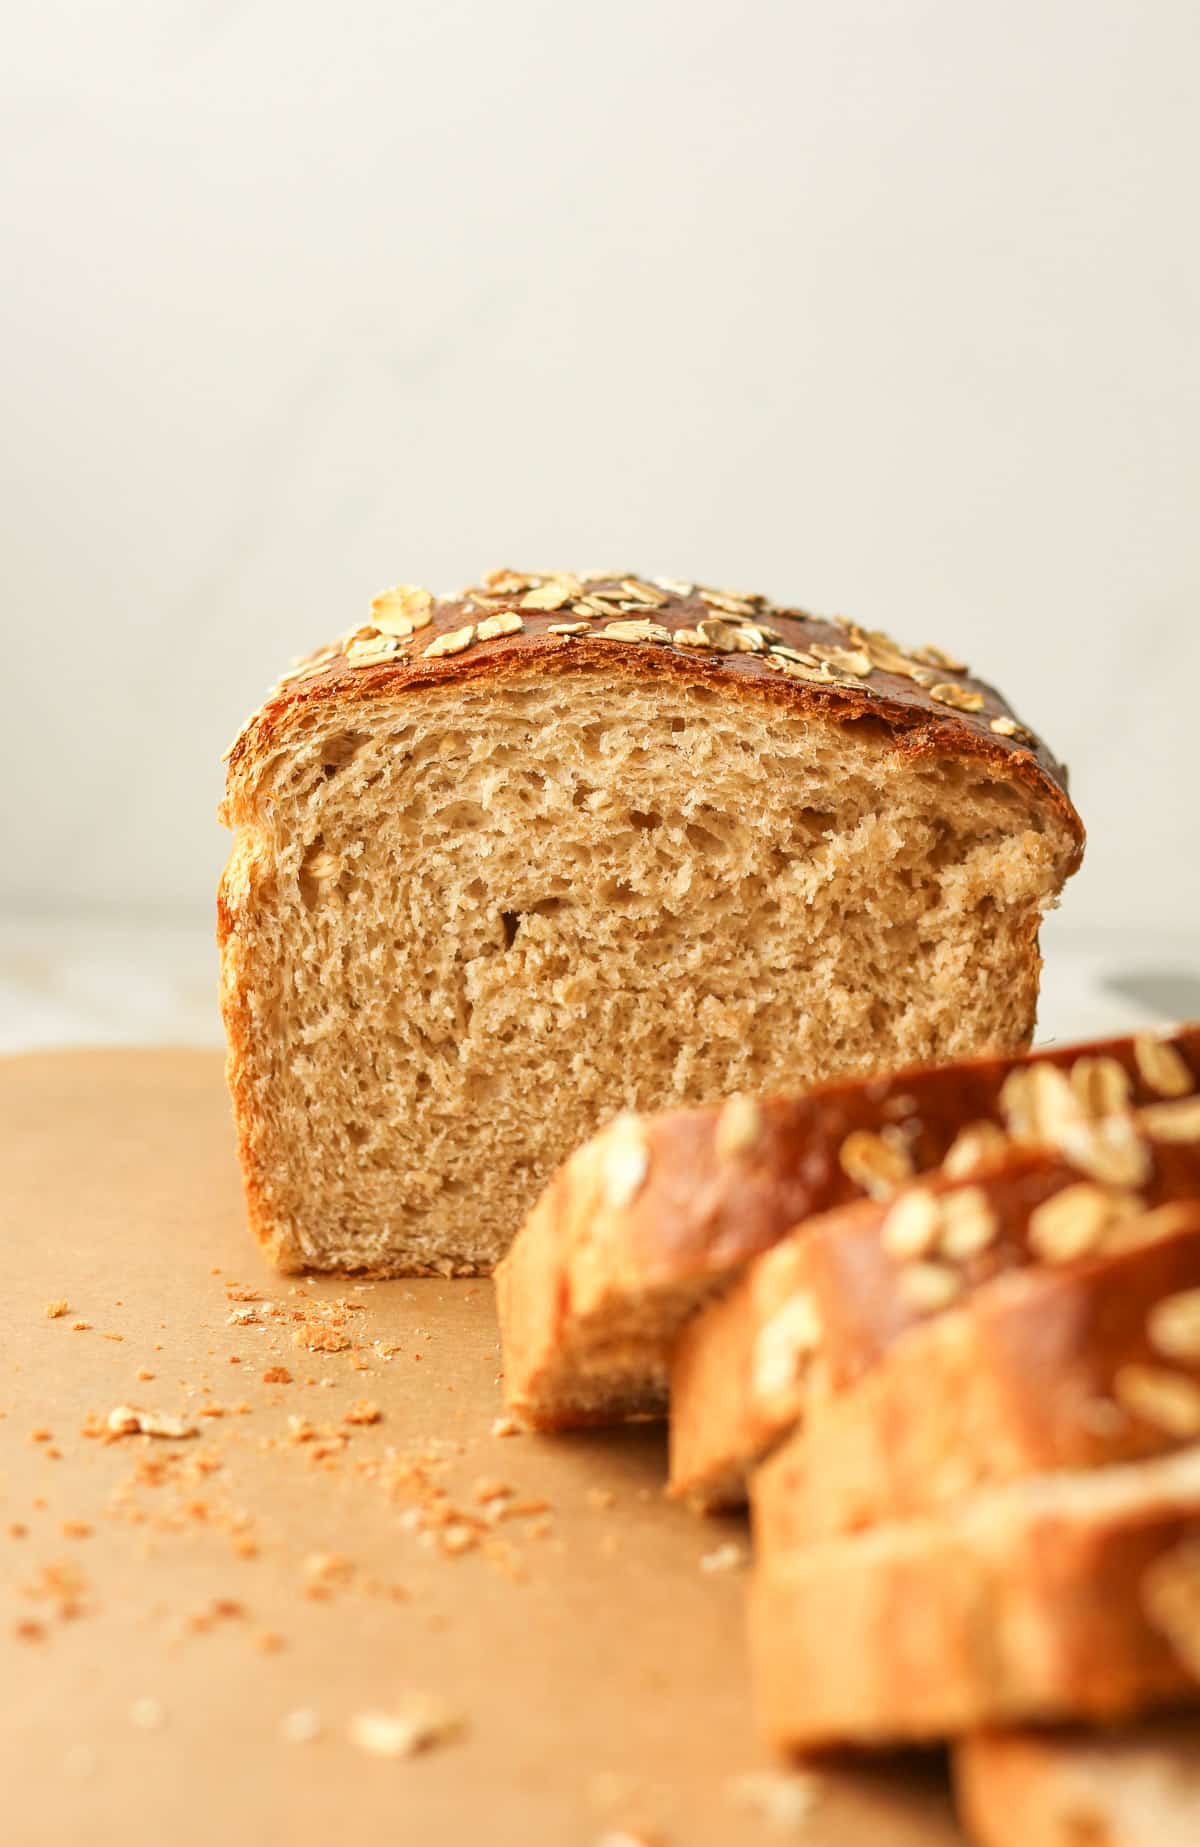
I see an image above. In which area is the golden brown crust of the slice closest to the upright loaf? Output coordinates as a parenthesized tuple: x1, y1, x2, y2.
(500, 1029, 1200, 1428)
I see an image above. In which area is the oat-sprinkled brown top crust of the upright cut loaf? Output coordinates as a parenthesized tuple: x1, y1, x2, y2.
(222, 571, 1084, 870)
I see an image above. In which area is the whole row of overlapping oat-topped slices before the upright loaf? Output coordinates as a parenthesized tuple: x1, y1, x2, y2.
(500, 1027, 1200, 1847)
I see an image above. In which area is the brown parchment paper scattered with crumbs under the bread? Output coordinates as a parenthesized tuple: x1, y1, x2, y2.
(0, 1051, 958, 1847)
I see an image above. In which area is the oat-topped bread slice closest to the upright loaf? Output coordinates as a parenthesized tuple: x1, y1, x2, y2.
(497, 1029, 1200, 1433)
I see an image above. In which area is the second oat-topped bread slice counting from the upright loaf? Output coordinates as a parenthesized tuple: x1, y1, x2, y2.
(670, 1063, 1200, 1509)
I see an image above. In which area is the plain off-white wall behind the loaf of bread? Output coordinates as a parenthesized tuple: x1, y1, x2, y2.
(0, 0, 1200, 1034)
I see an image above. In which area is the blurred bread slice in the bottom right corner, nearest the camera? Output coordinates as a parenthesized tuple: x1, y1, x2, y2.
(953, 1714, 1200, 1847)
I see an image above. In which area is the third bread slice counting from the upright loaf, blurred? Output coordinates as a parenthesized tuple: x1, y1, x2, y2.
(751, 1202, 1200, 1553)
